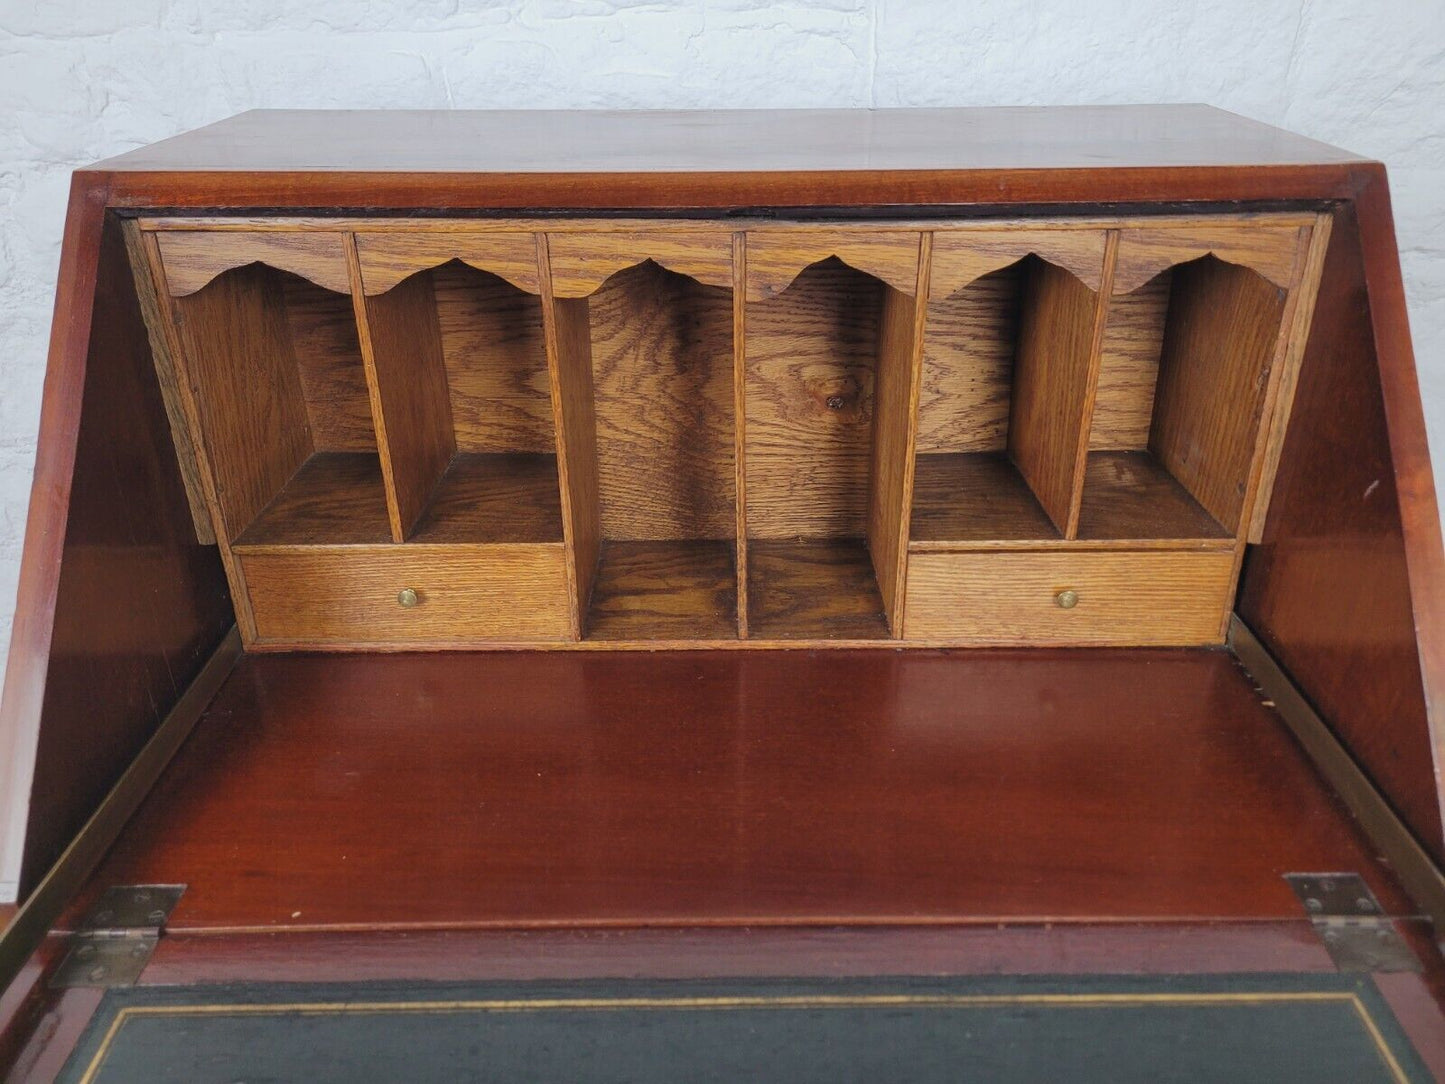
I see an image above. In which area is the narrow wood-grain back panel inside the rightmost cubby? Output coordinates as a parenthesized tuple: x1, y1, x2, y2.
(1090, 272, 1173, 451)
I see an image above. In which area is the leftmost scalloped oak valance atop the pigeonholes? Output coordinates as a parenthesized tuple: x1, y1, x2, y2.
(156, 230, 351, 298)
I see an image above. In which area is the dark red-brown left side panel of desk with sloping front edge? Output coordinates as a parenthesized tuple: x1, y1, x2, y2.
(0, 193, 234, 895)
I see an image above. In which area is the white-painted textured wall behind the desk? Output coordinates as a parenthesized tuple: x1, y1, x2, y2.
(0, 0, 1445, 890)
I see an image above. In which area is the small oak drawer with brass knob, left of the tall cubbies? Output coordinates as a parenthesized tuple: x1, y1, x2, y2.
(240, 545, 572, 646)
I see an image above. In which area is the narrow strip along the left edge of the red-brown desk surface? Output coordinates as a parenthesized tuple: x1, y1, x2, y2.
(0, 626, 241, 990)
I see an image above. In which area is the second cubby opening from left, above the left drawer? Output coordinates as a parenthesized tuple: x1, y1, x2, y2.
(366, 260, 562, 543)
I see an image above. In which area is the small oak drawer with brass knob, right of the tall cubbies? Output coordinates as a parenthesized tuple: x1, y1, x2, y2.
(905, 549, 1234, 645)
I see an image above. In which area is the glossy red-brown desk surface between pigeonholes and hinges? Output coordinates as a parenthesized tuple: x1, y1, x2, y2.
(67, 650, 1410, 931)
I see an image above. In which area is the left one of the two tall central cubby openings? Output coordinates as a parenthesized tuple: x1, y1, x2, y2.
(556, 259, 738, 640)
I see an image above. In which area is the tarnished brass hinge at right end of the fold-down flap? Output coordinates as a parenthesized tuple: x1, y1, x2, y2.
(1285, 873, 1423, 971)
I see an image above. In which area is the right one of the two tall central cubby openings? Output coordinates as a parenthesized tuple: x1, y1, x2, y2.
(744, 257, 915, 640)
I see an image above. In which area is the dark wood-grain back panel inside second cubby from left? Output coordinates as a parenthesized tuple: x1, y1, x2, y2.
(431, 265, 556, 454)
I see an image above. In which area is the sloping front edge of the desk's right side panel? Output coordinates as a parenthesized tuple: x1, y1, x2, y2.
(1355, 163, 1445, 838)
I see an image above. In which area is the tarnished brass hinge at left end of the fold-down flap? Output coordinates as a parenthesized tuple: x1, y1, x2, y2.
(51, 885, 185, 989)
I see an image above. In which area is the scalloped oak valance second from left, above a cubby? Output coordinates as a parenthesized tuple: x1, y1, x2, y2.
(355, 231, 542, 295)
